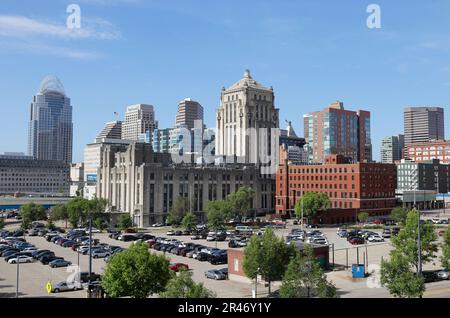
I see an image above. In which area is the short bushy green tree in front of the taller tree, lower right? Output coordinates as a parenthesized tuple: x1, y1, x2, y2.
(380, 251, 425, 298)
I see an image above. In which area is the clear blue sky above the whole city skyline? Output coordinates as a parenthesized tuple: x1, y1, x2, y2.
(0, 0, 450, 161)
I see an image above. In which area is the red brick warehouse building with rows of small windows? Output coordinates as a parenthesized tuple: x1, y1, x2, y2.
(275, 155, 397, 224)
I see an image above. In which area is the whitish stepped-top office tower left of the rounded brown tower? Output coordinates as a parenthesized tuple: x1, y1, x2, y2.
(122, 104, 158, 141)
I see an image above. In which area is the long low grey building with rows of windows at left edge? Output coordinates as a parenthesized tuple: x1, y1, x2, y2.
(0, 159, 70, 197)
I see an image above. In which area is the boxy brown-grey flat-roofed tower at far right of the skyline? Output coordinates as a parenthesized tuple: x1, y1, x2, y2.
(404, 107, 445, 146)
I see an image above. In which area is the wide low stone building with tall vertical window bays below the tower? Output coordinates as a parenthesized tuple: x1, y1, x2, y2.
(97, 144, 274, 227)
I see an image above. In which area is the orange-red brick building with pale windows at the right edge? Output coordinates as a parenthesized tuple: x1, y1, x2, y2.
(405, 140, 450, 164)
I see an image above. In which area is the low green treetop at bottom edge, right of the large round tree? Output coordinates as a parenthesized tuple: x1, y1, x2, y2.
(160, 271, 216, 298)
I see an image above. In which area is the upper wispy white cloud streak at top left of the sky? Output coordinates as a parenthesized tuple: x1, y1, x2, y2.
(0, 15, 120, 40)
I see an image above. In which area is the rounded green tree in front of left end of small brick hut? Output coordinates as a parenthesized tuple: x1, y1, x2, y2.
(243, 229, 295, 294)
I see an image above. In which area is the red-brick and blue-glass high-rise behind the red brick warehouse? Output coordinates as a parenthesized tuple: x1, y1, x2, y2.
(303, 101, 372, 163)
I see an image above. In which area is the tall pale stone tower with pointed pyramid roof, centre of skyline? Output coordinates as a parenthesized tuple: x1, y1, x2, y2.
(216, 70, 279, 163)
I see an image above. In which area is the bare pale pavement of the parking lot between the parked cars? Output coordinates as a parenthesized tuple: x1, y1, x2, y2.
(0, 219, 442, 298)
